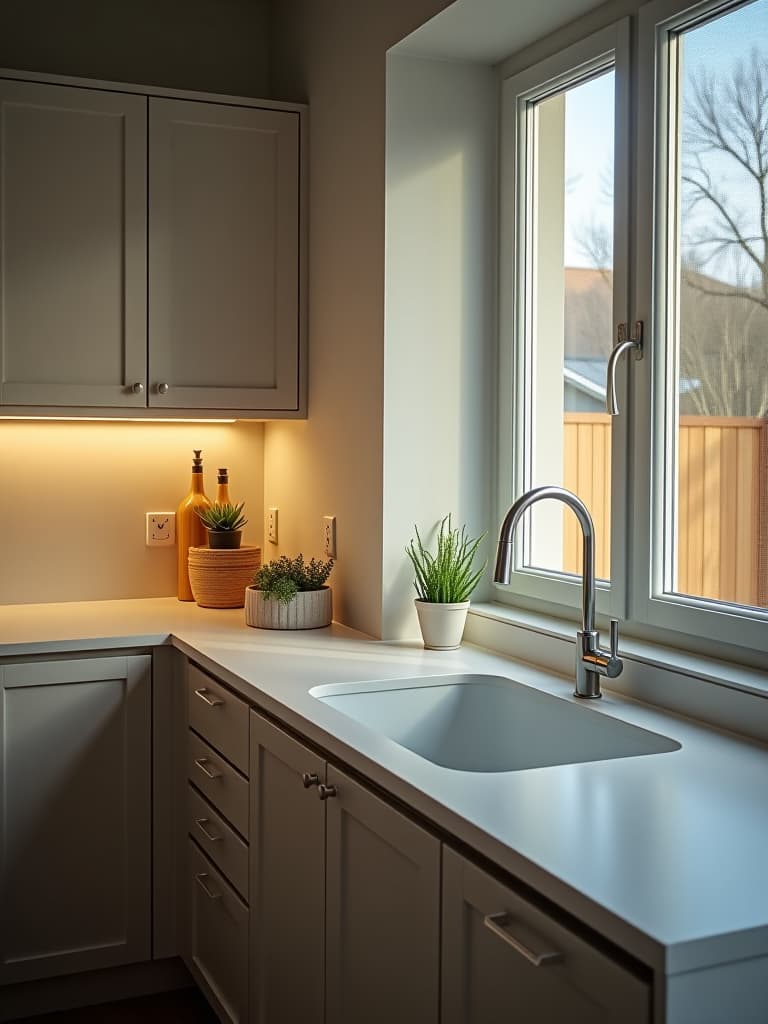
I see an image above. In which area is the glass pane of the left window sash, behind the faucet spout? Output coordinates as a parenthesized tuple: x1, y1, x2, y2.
(523, 71, 614, 580)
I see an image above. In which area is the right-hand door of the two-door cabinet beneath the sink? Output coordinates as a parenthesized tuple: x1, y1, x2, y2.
(326, 765, 440, 1024)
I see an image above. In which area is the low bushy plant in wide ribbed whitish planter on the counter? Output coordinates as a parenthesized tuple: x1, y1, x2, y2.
(246, 555, 334, 630)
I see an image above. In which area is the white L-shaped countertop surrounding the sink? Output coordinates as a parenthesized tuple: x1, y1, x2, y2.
(0, 598, 768, 974)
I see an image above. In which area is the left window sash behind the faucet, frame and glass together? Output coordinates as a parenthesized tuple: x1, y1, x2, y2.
(500, 23, 628, 613)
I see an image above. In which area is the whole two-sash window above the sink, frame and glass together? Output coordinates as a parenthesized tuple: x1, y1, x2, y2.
(499, 0, 768, 649)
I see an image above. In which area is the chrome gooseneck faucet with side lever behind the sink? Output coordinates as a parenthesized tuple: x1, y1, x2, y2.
(494, 486, 624, 699)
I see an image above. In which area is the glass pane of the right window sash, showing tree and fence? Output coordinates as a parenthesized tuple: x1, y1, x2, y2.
(665, 0, 768, 607)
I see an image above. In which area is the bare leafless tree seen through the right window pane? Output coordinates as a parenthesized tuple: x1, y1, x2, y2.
(680, 49, 768, 417)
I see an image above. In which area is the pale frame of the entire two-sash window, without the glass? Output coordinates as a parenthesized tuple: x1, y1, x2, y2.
(494, 0, 768, 656)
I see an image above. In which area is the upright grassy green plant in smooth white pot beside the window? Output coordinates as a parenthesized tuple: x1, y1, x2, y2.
(406, 515, 487, 650)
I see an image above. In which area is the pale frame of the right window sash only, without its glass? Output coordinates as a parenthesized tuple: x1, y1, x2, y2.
(630, 0, 768, 650)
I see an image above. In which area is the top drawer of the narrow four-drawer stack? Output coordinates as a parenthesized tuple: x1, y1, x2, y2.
(186, 663, 249, 775)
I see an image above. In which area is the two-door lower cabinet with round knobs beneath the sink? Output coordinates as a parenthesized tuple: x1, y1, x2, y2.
(250, 713, 440, 1024)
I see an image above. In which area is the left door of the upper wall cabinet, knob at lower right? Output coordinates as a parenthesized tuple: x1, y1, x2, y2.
(0, 80, 146, 408)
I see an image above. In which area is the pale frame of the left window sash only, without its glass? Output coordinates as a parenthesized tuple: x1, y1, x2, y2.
(494, 18, 631, 616)
